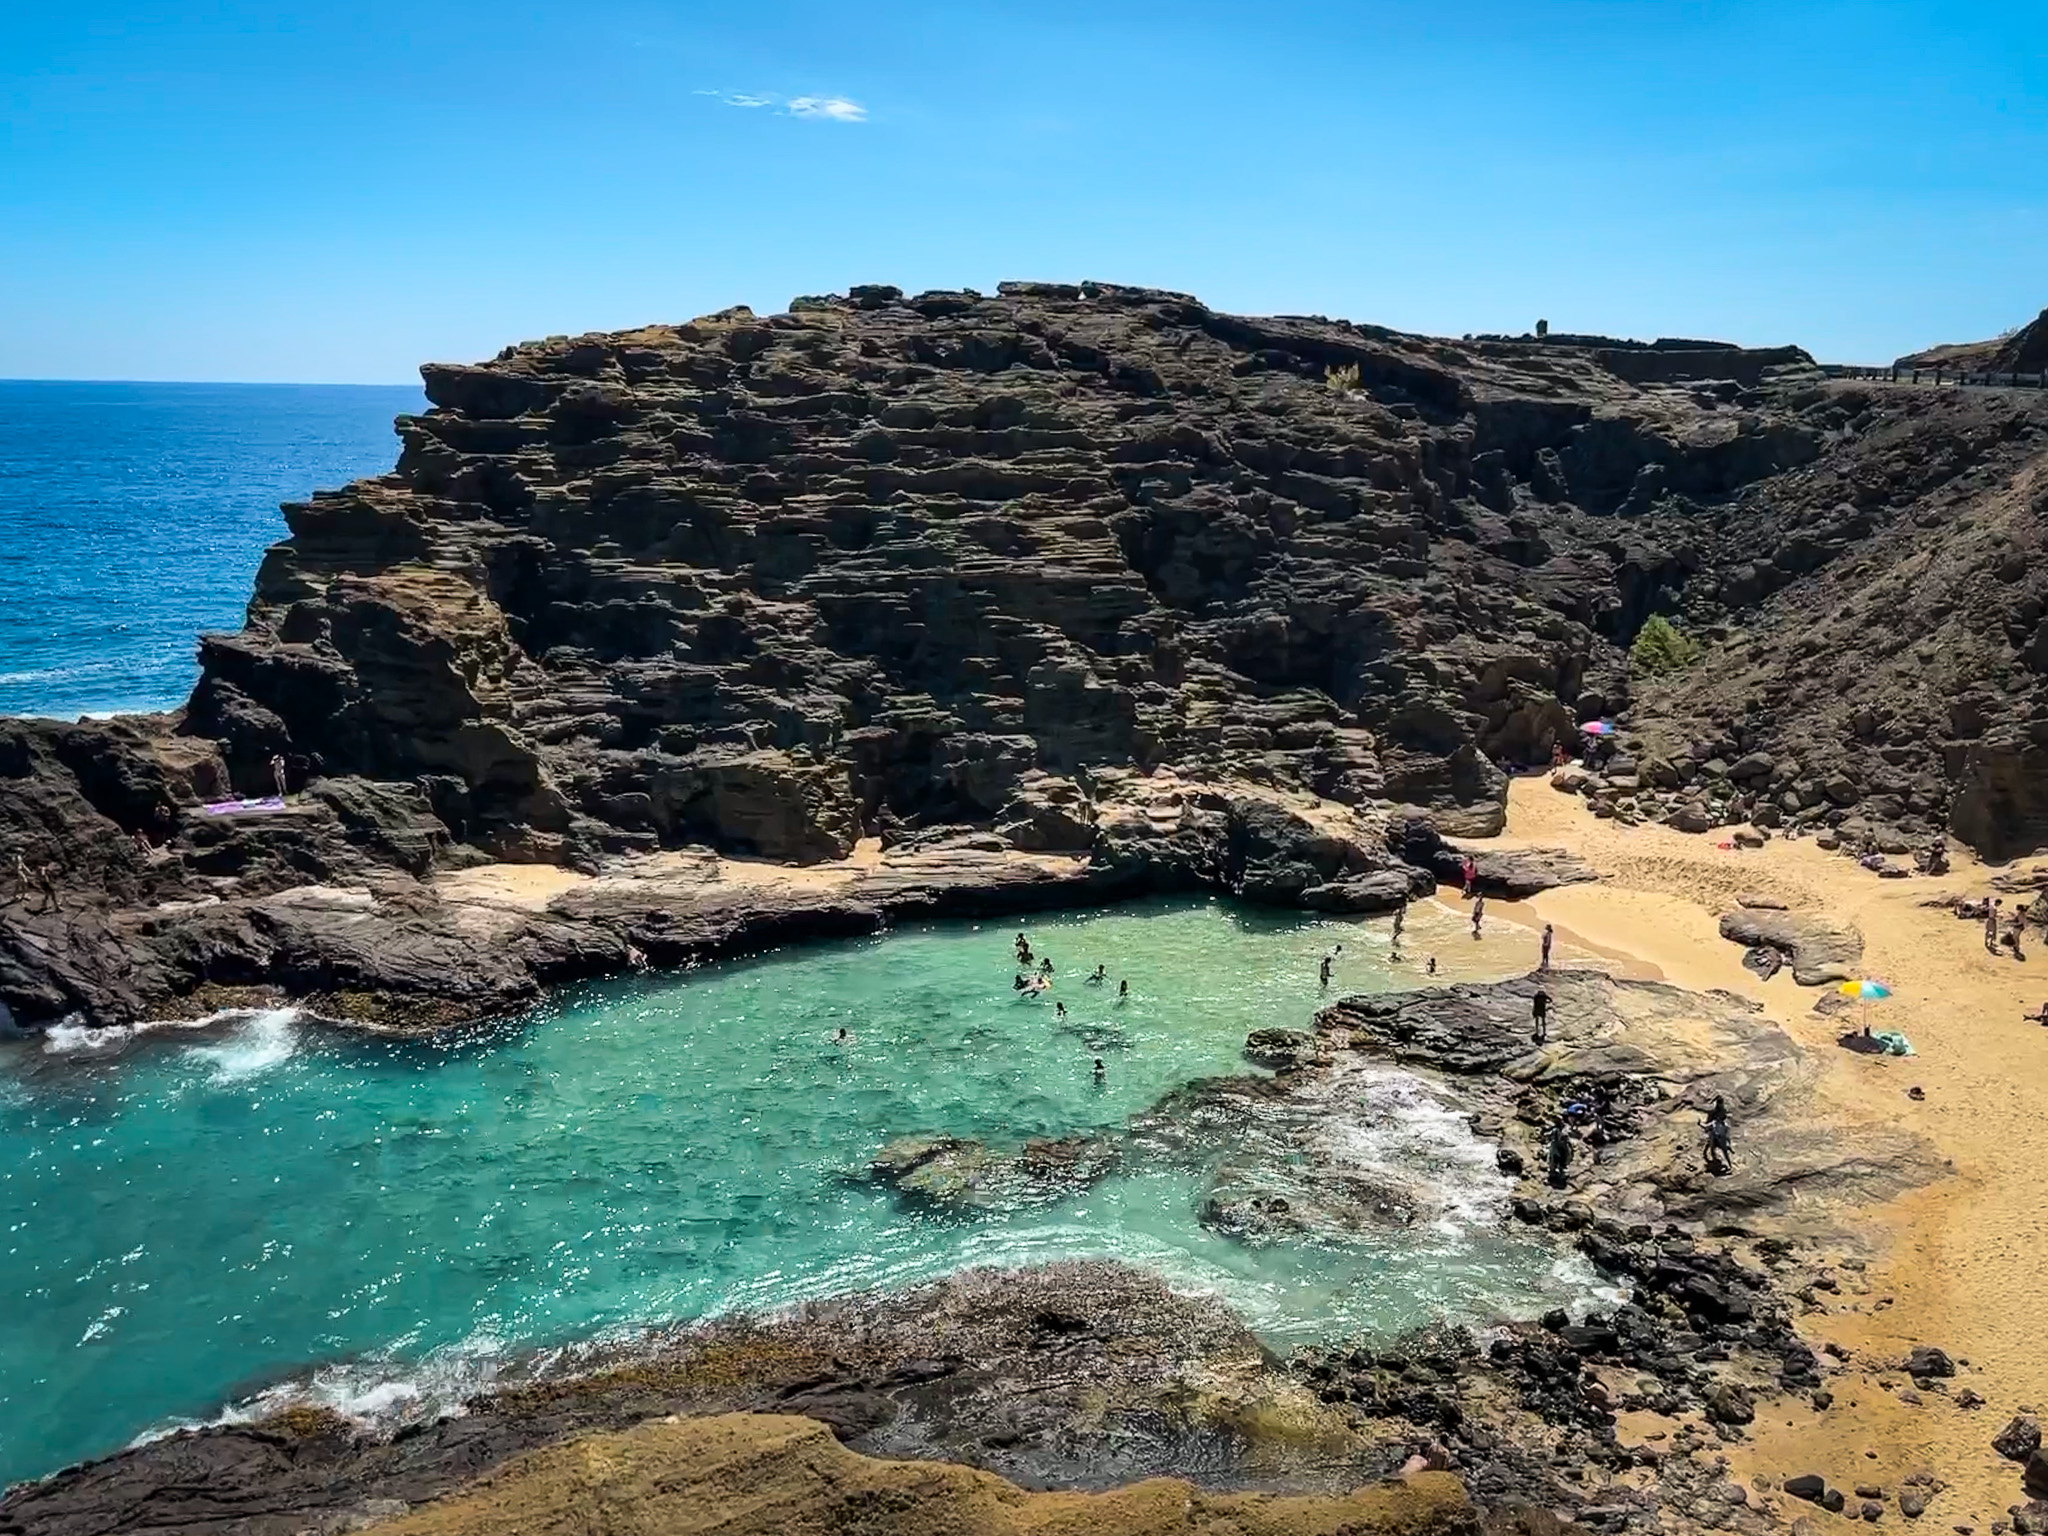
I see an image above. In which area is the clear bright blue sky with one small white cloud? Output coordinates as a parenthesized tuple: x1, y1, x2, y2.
(0, 0, 2048, 381)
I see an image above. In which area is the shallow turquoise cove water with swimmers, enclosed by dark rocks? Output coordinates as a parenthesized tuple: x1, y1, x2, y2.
(0, 903, 1567, 1479)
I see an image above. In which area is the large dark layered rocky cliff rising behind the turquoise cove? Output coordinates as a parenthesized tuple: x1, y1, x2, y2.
(0, 283, 2048, 1036)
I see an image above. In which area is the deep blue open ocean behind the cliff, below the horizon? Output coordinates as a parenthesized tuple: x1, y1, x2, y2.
(0, 379, 426, 719)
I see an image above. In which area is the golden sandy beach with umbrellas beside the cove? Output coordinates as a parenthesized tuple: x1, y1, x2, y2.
(1487, 778, 2048, 1528)
